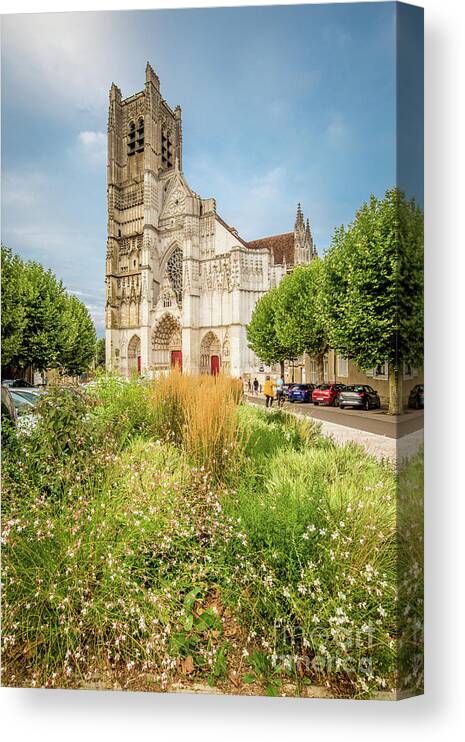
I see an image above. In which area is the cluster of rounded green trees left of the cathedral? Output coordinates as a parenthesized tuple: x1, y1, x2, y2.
(1, 245, 97, 376)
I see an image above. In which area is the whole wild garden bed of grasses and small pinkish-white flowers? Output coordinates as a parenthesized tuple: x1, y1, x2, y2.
(2, 373, 422, 697)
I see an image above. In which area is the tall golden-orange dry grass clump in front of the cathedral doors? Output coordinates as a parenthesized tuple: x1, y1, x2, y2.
(151, 369, 244, 480)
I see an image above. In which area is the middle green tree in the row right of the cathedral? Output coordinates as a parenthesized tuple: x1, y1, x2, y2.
(275, 260, 328, 383)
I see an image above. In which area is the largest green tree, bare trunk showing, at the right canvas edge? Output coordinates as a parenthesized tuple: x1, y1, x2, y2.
(321, 188, 423, 414)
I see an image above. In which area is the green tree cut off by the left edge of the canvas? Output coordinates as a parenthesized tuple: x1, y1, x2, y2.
(1, 245, 26, 367)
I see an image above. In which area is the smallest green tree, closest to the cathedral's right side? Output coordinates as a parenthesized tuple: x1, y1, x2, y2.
(247, 288, 294, 375)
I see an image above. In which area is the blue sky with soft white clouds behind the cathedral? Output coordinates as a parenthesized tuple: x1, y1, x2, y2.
(2, 3, 418, 335)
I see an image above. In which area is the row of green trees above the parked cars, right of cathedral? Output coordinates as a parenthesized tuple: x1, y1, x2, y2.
(247, 188, 423, 414)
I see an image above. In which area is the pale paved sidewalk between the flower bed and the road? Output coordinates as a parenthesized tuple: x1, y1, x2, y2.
(245, 397, 423, 464)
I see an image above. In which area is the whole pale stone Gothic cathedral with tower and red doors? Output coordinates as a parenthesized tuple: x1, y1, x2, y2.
(105, 64, 317, 377)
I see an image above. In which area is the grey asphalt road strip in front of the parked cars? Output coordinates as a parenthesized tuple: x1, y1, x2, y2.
(246, 395, 423, 438)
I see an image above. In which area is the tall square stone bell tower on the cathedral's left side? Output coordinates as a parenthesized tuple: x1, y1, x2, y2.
(105, 63, 182, 374)
